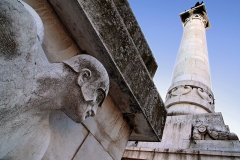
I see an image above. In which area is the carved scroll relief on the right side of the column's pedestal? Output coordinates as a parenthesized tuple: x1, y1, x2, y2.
(192, 121, 239, 140)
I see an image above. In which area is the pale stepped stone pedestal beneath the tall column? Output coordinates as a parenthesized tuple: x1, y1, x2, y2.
(123, 113, 240, 160)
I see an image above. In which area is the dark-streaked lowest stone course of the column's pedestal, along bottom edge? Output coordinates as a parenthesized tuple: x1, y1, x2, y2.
(122, 147, 240, 160)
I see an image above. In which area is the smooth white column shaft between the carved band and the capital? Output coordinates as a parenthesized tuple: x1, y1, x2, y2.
(172, 14, 211, 88)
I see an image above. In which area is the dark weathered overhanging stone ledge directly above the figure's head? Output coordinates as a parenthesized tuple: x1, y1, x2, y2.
(49, 0, 166, 141)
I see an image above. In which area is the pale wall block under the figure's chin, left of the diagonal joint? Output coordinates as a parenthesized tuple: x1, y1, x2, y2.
(43, 111, 89, 160)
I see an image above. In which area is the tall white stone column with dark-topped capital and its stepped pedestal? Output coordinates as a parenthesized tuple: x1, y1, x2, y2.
(123, 2, 240, 160)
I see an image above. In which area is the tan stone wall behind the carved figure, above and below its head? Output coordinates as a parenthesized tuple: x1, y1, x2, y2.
(20, 0, 132, 160)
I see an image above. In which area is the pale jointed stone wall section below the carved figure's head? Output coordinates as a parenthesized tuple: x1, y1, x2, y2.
(43, 96, 131, 160)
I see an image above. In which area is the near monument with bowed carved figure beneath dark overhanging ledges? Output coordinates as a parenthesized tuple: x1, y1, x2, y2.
(0, 0, 167, 160)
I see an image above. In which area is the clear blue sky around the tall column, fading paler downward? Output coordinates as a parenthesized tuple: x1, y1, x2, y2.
(129, 0, 240, 138)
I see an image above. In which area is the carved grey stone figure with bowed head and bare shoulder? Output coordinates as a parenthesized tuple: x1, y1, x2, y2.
(0, 0, 109, 159)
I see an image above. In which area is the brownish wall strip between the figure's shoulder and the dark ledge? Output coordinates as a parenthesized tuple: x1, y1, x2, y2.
(24, 0, 82, 62)
